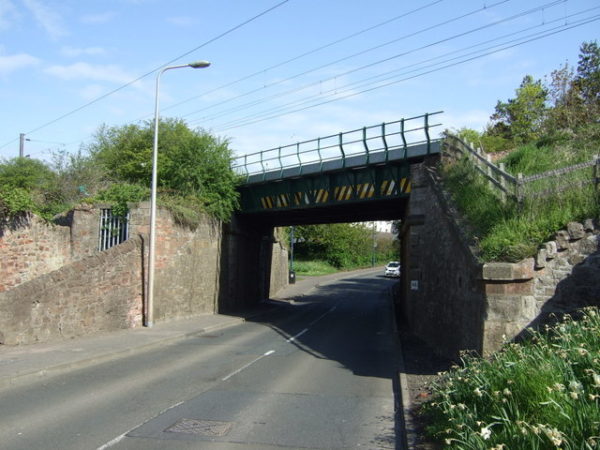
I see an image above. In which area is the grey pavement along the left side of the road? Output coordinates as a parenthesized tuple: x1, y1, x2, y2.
(0, 268, 381, 389)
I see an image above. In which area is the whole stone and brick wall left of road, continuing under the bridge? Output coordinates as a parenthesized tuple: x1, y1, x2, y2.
(0, 206, 287, 344)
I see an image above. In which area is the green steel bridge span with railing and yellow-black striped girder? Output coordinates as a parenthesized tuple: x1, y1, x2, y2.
(232, 113, 440, 213)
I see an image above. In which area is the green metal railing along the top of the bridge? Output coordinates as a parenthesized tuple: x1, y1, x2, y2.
(231, 111, 443, 181)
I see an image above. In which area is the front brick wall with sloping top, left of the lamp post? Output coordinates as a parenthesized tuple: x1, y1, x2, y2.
(0, 238, 142, 345)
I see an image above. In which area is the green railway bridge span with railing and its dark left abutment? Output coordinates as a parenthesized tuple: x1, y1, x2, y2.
(219, 113, 441, 312)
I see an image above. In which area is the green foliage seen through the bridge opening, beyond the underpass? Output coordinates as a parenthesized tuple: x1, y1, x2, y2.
(294, 223, 373, 269)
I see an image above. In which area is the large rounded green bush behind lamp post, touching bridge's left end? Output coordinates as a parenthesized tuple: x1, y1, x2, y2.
(88, 119, 238, 221)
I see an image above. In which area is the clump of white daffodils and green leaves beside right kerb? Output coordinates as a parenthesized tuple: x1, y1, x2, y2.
(423, 308, 600, 450)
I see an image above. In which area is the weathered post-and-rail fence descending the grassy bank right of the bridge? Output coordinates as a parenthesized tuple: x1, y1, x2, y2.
(442, 135, 600, 203)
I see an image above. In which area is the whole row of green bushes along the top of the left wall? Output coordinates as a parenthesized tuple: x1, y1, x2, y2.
(0, 119, 238, 227)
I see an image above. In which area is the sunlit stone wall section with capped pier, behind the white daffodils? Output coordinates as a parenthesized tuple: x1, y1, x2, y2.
(482, 219, 600, 353)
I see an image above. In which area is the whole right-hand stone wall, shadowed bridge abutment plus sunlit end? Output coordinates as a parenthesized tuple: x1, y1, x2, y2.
(398, 161, 600, 358)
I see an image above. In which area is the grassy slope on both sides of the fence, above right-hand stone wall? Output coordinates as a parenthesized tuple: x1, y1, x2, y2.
(444, 124, 600, 261)
